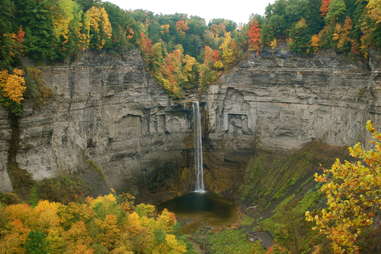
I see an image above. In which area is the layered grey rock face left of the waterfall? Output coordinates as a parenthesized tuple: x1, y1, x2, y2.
(0, 52, 191, 192)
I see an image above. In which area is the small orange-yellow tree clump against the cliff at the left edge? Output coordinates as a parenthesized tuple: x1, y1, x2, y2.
(0, 69, 26, 103)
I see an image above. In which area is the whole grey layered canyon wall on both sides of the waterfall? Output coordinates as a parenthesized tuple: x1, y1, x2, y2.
(0, 49, 381, 193)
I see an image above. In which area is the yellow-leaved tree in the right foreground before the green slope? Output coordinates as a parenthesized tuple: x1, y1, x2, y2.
(306, 121, 381, 254)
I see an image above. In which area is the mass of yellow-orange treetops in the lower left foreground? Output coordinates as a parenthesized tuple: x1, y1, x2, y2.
(0, 194, 186, 254)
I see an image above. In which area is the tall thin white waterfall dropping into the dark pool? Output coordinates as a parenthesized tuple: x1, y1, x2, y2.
(192, 101, 205, 193)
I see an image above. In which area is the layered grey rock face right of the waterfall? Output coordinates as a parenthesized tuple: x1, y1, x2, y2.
(207, 50, 381, 152)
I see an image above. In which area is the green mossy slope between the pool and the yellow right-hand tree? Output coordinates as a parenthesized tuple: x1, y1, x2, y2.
(240, 142, 345, 253)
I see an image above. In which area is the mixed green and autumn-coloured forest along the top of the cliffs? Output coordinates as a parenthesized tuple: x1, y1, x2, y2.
(0, 0, 381, 106)
